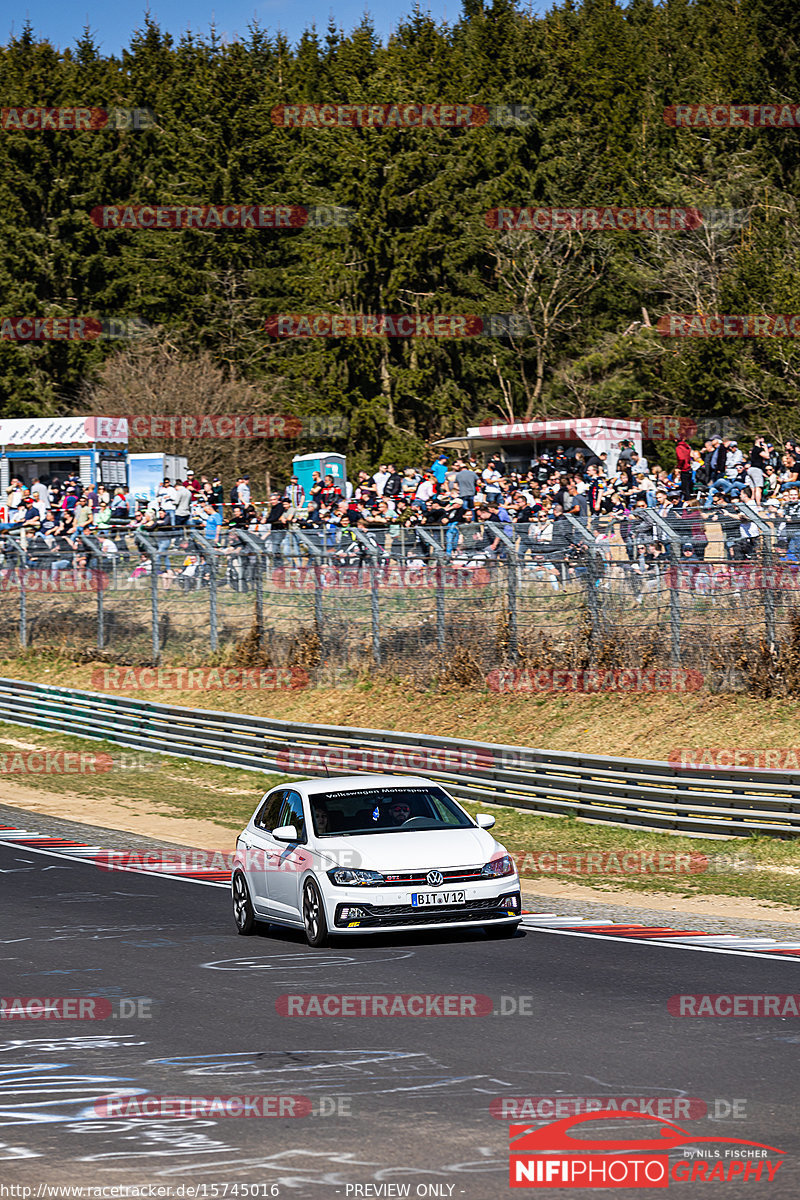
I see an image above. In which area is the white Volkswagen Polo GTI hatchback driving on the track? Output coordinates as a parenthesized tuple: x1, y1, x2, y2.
(231, 775, 522, 946)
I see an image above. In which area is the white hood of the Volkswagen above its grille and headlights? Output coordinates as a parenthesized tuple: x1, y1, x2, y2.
(318, 828, 505, 872)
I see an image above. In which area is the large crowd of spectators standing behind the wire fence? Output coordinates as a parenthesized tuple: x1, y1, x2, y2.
(0, 437, 800, 590)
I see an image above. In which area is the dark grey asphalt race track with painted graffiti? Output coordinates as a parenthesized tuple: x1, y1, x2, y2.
(0, 830, 800, 1200)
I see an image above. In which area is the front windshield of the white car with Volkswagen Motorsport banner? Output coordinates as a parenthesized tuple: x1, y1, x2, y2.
(308, 786, 473, 838)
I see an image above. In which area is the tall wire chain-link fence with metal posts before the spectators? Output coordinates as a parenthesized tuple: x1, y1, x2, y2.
(0, 503, 800, 695)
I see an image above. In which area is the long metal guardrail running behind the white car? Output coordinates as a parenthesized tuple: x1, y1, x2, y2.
(0, 678, 800, 838)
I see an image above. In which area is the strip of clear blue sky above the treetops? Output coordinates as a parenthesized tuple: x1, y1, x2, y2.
(7, 0, 548, 54)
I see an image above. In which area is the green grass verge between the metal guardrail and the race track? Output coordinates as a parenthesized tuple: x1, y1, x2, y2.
(0, 724, 800, 906)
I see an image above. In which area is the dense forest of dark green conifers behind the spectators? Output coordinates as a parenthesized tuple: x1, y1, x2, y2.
(0, 0, 800, 472)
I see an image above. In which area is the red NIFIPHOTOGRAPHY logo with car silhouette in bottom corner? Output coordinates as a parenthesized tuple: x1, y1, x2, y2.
(509, 1109, 783, 1188)
